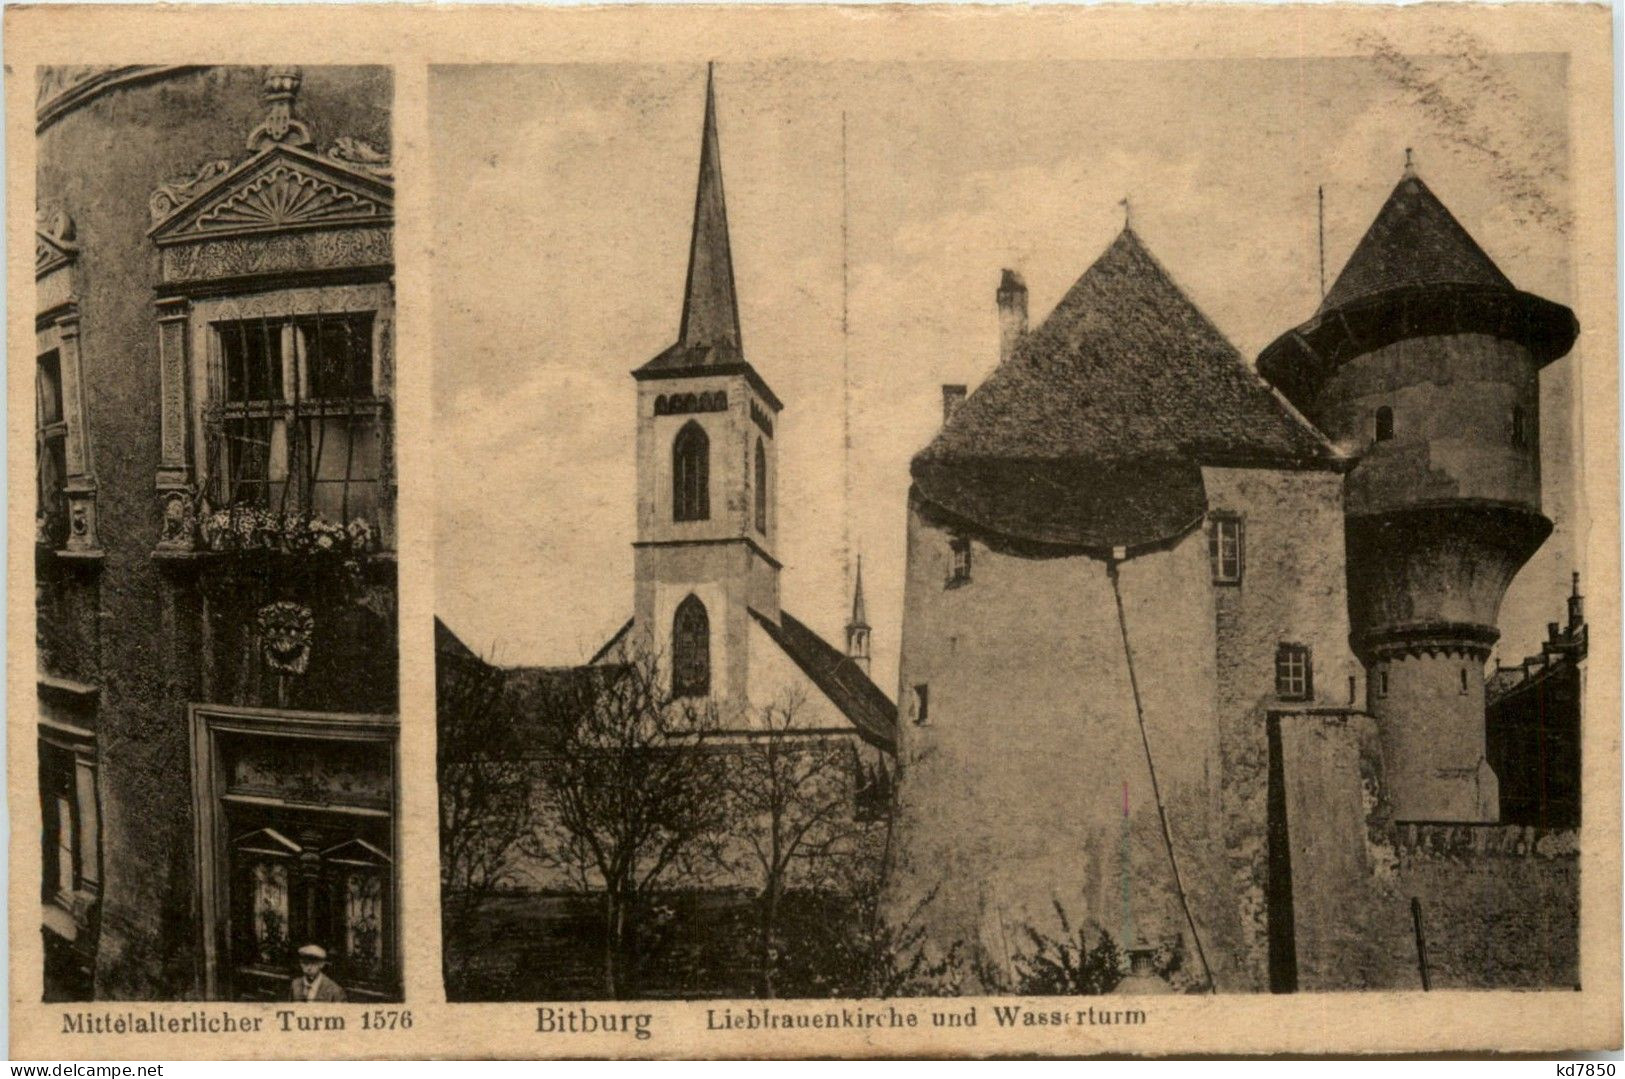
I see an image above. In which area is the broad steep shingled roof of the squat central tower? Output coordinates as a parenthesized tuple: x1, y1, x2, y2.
(913, 228, 1341, 549)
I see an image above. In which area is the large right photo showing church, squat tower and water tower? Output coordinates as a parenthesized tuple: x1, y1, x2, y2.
(427, 56, 1588, 1001)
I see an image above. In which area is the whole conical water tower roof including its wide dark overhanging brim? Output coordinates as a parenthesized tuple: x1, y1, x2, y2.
(1258, 167, 1580, 410)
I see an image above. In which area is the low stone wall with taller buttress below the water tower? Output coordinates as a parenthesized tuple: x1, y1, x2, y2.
(1271, 715, 1580, 990)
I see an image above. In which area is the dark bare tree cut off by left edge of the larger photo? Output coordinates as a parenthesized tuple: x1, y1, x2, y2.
(436, 655, 533, 993)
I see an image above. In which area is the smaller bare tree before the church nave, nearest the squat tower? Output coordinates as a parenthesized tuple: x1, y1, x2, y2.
(728, 691, 876, 996)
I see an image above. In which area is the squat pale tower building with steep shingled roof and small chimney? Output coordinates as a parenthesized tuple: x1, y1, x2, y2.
(892, 229, 1359, 988)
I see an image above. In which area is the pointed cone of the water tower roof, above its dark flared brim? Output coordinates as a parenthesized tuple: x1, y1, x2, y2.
(1320, 172, 1516, 312)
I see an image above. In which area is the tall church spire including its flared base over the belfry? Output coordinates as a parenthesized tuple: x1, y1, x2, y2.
(632, 68, 780, 408)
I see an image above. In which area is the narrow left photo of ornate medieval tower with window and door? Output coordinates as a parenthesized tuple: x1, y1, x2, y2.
(36, 67, 401, 1003)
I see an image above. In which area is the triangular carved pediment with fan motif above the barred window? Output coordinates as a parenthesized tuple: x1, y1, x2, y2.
(150, 143, 393, 245)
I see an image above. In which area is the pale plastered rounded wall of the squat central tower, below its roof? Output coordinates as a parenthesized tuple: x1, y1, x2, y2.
(887, 505, 1237, 985)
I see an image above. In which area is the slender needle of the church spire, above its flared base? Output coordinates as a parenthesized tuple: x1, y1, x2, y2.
(678, 63, 741, 358)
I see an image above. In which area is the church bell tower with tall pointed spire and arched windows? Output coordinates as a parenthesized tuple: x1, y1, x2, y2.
(632, 68, 783, 700)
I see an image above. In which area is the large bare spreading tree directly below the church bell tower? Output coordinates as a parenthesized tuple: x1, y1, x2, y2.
(527, 652, 726, 999)
